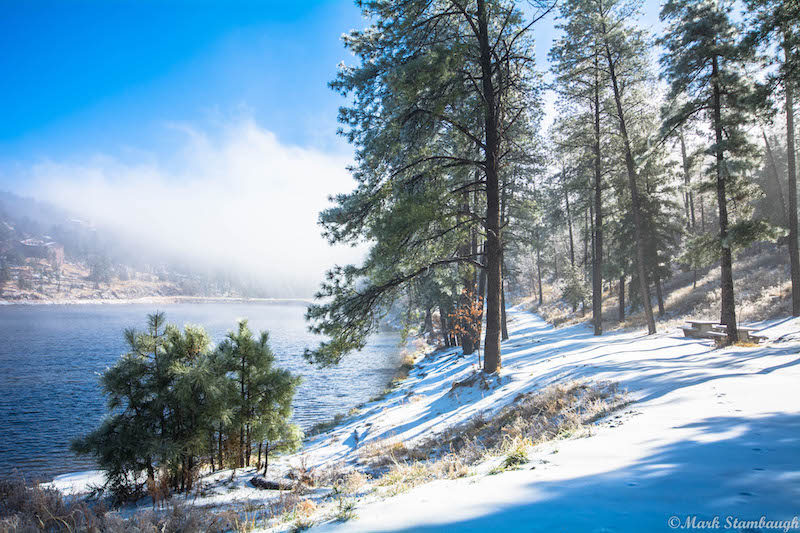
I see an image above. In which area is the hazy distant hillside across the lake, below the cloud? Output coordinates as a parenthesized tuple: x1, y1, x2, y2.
(0, 192, 273, 302)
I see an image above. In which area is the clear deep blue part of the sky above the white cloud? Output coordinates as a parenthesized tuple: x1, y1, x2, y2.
(0, 0, 363, 182)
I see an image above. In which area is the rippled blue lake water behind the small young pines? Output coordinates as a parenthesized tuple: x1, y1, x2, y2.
(0, 302, 402, 479)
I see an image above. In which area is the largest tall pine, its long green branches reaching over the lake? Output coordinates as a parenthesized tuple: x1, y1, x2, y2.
(306, 0, 538, 373)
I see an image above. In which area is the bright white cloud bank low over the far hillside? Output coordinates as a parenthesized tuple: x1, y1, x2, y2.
(21, 119, 362, 295)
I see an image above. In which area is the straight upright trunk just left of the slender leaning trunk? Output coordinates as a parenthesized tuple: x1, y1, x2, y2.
(592, 64, 603, 335)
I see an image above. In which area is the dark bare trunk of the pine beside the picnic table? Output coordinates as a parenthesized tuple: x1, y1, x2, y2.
(711, 56, 739, 343)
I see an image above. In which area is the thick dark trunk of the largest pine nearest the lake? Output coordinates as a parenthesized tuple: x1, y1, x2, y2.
(477, 0, 503, 374)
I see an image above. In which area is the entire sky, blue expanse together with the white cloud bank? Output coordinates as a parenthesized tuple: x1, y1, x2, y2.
(0, 0, 658, 296)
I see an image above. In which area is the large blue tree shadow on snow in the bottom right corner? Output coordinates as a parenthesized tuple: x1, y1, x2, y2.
(380, 414, 800, 532)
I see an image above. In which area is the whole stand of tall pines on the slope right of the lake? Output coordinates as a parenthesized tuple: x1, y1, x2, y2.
(307, 0, 800, 373)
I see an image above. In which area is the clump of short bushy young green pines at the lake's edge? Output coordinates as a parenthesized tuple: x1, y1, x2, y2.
(72, 313, 302, 501)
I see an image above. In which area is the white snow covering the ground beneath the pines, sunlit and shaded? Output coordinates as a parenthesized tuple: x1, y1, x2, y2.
(50, 309, 800, 532)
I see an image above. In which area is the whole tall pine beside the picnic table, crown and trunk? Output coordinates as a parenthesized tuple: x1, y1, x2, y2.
(661, 0, 763, 342)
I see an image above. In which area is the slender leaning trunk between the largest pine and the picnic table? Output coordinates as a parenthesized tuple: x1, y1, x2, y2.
(603, 39, 656, 335)
